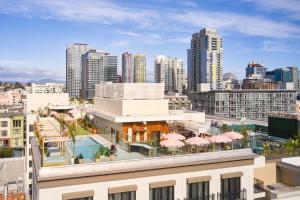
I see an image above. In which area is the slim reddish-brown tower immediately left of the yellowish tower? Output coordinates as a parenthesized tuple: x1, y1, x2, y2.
(122, 52, 134, 83)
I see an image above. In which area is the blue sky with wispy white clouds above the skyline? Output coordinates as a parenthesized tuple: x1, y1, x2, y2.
(0, 0, 300, 81)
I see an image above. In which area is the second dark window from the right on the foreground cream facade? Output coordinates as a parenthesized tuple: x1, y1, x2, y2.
(187, 181, 209, 200)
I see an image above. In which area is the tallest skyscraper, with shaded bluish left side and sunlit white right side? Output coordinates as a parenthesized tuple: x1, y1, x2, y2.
(188, 28, 223, 91)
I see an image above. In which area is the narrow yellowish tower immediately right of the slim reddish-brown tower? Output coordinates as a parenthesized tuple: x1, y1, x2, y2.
(134, 54, 146, 83)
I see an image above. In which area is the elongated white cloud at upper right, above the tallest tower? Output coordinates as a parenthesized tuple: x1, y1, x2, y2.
(173, 11, 300, 38)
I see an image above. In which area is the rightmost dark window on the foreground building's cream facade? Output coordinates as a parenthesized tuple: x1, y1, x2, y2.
(220, 177, 241, 200)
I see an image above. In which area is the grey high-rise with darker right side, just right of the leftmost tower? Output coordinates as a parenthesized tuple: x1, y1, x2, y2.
(81, 50, 118, 99)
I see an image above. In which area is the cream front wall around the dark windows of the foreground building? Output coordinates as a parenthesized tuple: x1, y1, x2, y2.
(39, 166, 254, 200)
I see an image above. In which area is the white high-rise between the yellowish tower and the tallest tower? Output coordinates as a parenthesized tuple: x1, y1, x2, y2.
(154, 55, 186, 93)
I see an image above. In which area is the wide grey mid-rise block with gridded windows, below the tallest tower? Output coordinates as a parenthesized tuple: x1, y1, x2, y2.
(190, 90, 297, 121)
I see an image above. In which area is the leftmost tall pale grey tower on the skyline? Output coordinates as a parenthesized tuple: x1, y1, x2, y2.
(66, 43, 89, 97)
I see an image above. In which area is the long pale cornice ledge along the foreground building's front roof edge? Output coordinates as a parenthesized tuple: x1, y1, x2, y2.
(33, 146, 258, 181)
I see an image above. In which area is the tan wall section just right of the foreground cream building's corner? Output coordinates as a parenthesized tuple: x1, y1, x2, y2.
(254, 162, 277, 185)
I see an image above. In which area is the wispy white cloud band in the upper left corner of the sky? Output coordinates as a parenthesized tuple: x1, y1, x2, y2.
(0, 0, 158, 24)
